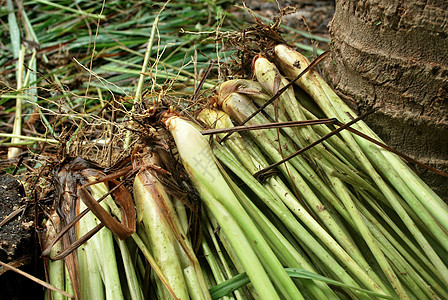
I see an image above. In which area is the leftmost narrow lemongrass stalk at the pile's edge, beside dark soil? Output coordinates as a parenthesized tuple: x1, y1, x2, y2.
(45, 211, 66, 300)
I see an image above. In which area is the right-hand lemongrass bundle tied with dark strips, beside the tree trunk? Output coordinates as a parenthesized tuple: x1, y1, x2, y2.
(202, 45, 448, 299)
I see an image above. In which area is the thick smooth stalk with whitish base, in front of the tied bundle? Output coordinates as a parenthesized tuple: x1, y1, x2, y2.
(165, 116, 300, 299)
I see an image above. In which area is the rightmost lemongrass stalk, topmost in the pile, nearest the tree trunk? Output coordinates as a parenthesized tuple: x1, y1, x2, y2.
(275, 45, 448, 283)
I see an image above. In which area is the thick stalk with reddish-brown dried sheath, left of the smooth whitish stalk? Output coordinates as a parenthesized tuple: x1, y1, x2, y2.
(133, 150, 210, 299)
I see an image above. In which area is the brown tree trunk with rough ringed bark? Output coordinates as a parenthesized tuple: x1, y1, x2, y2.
(326, 0, 448, 201)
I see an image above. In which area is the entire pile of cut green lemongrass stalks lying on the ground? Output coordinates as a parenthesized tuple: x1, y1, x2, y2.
(36, 38, 448, 300)
